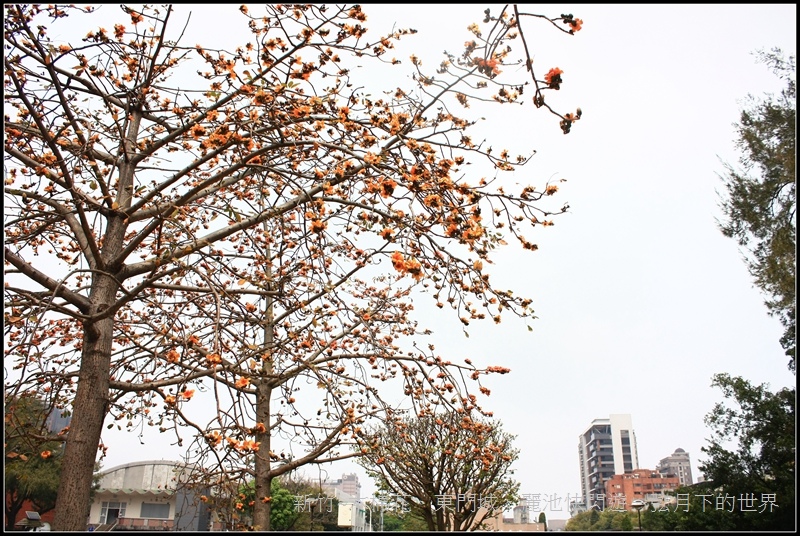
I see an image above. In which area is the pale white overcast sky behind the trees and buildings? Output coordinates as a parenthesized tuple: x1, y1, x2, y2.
(48, 4, 797, 519)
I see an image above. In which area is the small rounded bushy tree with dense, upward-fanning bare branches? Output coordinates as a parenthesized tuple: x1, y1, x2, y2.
(359, 411, 519, 531)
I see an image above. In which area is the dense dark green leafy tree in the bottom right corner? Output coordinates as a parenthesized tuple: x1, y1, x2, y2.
(700, 374, 797, 530)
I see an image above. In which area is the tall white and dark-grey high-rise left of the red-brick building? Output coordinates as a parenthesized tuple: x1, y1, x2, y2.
(578, 414, 639, 509)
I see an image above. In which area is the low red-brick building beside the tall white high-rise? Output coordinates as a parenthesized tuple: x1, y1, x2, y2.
(605, 469, 679, 510)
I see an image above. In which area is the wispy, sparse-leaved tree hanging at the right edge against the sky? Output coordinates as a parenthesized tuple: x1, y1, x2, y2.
(720, 49, 797, 371)
